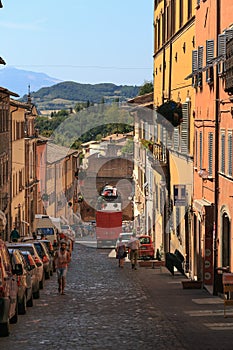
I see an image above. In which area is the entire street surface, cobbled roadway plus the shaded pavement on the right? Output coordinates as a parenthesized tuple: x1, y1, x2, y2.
(0, 244, 233, 350)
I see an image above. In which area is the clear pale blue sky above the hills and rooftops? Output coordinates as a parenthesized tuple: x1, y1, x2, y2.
(0, 0, 154, 86)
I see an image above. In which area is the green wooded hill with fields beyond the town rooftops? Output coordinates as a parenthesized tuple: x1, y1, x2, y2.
(20, 81, 140, 111)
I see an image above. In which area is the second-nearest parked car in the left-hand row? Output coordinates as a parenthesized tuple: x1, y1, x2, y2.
(8, 247, 33, 315)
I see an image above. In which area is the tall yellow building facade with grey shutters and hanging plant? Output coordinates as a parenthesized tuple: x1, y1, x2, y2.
(154, 0, 197, 272)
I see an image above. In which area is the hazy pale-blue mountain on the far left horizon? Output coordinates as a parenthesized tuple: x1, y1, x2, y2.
(0, 67, 61, 96)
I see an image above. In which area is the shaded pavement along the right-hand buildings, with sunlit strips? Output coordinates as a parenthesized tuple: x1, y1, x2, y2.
(109, 252, 233, 350)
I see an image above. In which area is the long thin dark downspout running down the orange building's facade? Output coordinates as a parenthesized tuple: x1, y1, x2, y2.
(213, 0, 221, 295)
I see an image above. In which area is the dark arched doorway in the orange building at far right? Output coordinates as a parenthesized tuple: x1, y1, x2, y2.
(222, 213, 231, 267)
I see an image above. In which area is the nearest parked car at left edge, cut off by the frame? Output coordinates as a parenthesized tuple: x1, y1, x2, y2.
(0, 239, 20, 337)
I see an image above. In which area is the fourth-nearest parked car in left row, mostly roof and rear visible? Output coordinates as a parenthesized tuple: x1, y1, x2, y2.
(8, 242, 45, 289)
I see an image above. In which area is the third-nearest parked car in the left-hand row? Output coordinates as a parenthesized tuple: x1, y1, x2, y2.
(20, 250, 40, 299)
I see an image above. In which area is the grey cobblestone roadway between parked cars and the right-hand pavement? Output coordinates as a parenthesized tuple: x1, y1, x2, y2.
(0, 244, 188, 350)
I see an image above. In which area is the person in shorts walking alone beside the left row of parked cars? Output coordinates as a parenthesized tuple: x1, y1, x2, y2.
(54, 240, 70, 294)
